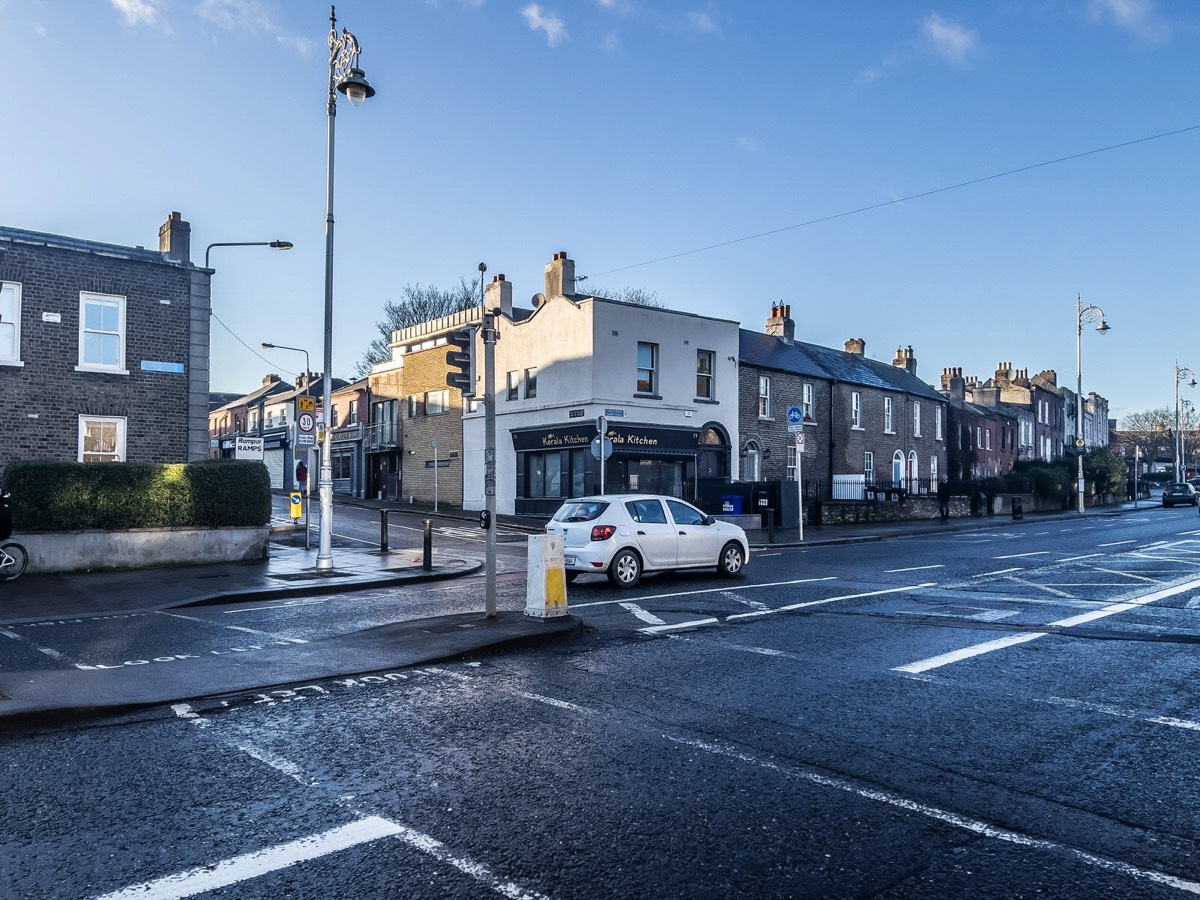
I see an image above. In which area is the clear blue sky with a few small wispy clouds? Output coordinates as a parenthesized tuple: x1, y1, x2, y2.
(0, 0, 1200, 418)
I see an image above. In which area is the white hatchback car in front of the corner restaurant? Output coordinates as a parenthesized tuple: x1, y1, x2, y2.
(546, 493, 750, 588)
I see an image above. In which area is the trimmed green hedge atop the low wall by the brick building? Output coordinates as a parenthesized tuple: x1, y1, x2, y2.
(4, 460, 271, 532)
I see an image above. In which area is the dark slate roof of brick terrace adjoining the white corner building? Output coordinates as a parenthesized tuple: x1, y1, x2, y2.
(738, 329, 946, 401)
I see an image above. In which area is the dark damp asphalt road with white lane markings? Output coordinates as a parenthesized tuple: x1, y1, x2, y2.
(0, 508, 1200, 898)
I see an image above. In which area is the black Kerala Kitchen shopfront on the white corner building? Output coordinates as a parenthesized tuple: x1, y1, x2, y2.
(510, 420, 730, 516)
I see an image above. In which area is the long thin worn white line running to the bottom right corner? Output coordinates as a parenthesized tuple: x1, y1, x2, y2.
(666, 734, 1200, 894)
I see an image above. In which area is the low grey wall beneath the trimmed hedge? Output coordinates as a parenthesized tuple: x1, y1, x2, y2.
(14, 526, 270, 574)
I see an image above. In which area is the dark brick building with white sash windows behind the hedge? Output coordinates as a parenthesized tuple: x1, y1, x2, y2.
(0, 212, 209, 468)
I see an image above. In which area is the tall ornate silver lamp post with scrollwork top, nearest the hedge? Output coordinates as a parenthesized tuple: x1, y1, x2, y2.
(317, 6, 376, 569)
